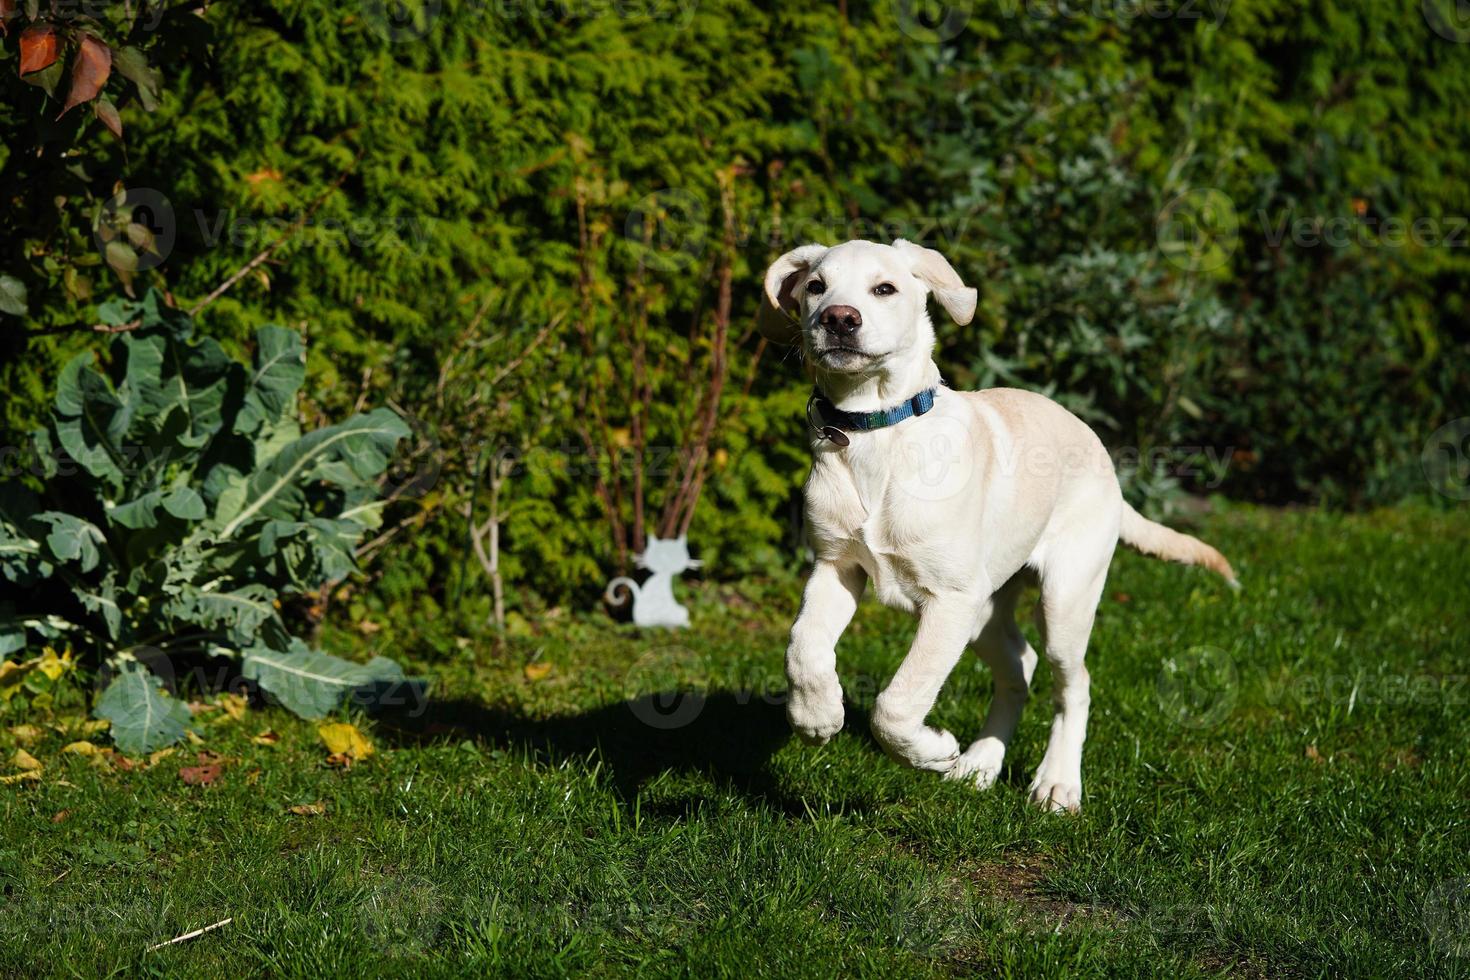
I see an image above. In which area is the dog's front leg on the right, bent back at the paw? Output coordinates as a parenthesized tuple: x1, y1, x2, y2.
(873, 595, 989, 773)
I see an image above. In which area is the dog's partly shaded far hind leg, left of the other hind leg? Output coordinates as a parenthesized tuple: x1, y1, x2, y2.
(947, 574, 1036, 789)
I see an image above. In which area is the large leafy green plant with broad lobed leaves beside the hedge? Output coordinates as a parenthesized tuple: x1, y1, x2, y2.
(0, 292, 409, 751)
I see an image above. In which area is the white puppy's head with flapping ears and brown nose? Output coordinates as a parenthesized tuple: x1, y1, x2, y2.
(760, 238, 976, 375)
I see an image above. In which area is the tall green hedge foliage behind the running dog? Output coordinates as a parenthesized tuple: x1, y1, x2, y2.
(0, 0, 1470, 617)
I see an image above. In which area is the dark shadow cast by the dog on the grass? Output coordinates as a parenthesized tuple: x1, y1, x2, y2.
(379, 691, 867, 814)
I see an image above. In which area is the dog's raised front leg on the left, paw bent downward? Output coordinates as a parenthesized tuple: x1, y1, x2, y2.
(786, 561, 867, 745)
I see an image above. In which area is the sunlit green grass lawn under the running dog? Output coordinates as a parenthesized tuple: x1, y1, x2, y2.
(0, 508, 1470, 977)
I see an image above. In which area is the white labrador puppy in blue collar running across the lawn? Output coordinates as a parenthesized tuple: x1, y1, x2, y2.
(761, 241, 1235, 810)
